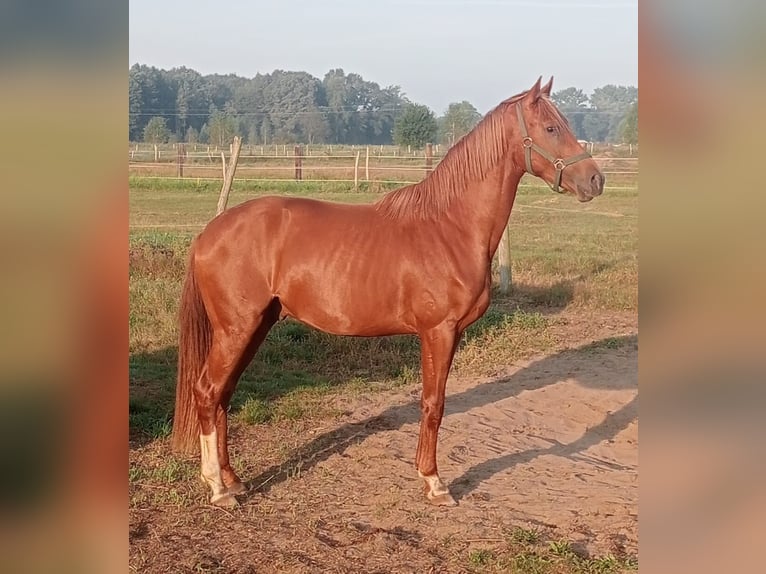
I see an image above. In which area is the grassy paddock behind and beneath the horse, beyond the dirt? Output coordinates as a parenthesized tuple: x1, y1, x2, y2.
(129, 177, 638, 440)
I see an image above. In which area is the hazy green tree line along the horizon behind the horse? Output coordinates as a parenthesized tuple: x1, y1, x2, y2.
(128, 64, 638, 148)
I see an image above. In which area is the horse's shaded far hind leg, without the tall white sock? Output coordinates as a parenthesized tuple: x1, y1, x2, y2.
(215, 301, 279, 494)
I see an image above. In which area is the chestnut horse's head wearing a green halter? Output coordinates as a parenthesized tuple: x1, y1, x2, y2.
(507, 78, 605, 201)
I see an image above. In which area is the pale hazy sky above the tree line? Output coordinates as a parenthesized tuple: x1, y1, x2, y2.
(130, 0, 638, 114)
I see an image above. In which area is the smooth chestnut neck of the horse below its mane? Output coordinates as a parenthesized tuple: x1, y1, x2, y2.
(453, 158, 524, 257)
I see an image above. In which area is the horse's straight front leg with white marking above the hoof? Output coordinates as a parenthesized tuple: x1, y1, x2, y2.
(415, 324, 460, 506)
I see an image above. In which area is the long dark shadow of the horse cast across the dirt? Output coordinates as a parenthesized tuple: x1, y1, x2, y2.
(244, 335, 638, 506)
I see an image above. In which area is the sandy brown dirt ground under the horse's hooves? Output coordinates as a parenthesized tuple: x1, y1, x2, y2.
(130, 319, 638, 572)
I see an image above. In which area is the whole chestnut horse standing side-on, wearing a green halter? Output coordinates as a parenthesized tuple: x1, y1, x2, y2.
(173, 78, 604, 506)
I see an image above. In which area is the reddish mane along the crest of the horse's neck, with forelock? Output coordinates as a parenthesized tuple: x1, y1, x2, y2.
(375, 91, 566, 220)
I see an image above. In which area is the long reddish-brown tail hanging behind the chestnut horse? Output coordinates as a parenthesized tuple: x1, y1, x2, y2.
(173, 248, 213, 454)
